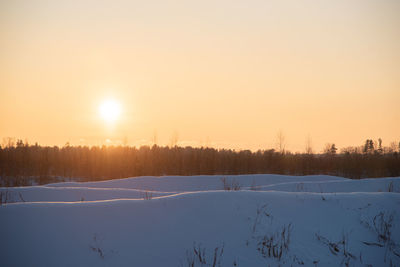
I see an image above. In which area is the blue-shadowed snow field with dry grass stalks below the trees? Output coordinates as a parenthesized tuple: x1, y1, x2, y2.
(0, 175, 400, 266)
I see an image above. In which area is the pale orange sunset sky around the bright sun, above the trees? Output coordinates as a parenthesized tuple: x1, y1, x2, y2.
(0, 0, 400, 152)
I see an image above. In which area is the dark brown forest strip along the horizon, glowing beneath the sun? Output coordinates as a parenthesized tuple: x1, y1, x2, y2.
(0, 139, 400, 186)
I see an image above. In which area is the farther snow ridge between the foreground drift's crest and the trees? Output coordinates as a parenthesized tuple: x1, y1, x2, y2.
(0, 175, 348, 202)
